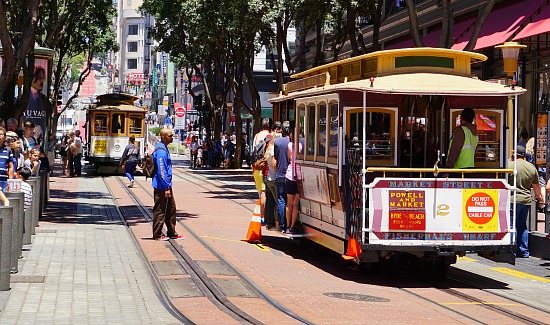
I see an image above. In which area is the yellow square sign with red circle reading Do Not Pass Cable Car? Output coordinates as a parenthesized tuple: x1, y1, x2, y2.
(462, 189, 498, 232)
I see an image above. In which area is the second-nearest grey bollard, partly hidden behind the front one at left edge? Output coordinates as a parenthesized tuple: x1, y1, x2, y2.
(6, 192, 25, 273)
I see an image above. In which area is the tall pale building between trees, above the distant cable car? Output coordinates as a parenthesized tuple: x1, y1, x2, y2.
(114, 0, 153, 95)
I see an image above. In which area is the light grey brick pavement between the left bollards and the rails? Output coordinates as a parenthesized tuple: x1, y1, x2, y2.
(0, 173, 179, 324)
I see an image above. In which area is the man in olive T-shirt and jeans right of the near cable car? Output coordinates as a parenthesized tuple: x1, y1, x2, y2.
(509, 146, 544, 257)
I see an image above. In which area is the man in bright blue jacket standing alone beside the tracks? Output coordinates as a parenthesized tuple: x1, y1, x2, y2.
(153, 129, 182, 240)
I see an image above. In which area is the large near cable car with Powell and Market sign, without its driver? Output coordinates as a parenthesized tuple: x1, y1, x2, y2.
(269, 48, 525, 271)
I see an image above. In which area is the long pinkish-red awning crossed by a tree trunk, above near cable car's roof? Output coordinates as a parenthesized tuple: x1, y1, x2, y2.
(452, 0, 546, 50)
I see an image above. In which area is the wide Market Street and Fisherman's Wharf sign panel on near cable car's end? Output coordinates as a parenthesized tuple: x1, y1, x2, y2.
(368, 178, 511, 245)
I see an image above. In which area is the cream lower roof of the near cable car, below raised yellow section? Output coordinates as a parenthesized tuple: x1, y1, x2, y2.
(268, 73, 526, 103)
